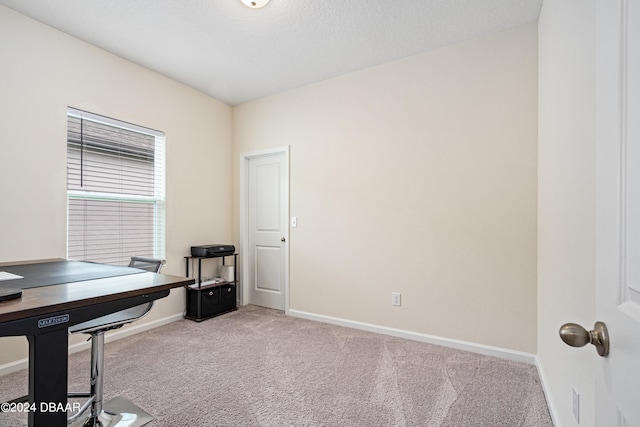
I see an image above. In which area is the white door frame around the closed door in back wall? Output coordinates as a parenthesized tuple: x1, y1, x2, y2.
(240, 145, 290, 314)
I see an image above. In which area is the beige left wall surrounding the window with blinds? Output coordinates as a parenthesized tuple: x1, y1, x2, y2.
(0, 6, 232, 365)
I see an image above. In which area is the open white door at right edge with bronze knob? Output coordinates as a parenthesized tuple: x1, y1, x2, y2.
(596, 0, 640, 427)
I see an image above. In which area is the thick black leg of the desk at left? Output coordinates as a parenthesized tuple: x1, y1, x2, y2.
(27, 328, 69, 427)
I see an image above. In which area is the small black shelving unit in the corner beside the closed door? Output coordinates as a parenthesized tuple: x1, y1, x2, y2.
(184, 254, 238, 322)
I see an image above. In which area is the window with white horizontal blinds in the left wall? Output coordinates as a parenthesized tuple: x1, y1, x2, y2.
(67, 108, 165, 265)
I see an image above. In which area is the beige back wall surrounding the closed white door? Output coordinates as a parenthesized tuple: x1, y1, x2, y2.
(233, 24, 537, 353)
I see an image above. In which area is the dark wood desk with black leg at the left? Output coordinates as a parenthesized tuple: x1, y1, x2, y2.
(0, 264, 194, 427)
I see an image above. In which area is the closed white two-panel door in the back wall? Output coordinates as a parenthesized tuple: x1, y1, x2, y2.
(244, 151, 289, 310)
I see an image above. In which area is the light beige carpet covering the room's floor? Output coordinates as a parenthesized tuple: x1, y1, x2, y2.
(0, 306, 553, 427)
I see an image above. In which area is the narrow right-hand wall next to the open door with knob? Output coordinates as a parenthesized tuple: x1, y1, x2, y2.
(538, 0, 596, 427)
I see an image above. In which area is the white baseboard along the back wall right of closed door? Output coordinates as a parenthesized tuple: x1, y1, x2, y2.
(287, 309, 536, 365)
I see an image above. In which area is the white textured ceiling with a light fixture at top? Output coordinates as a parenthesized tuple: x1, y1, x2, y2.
(0, 0, 542, 105)
